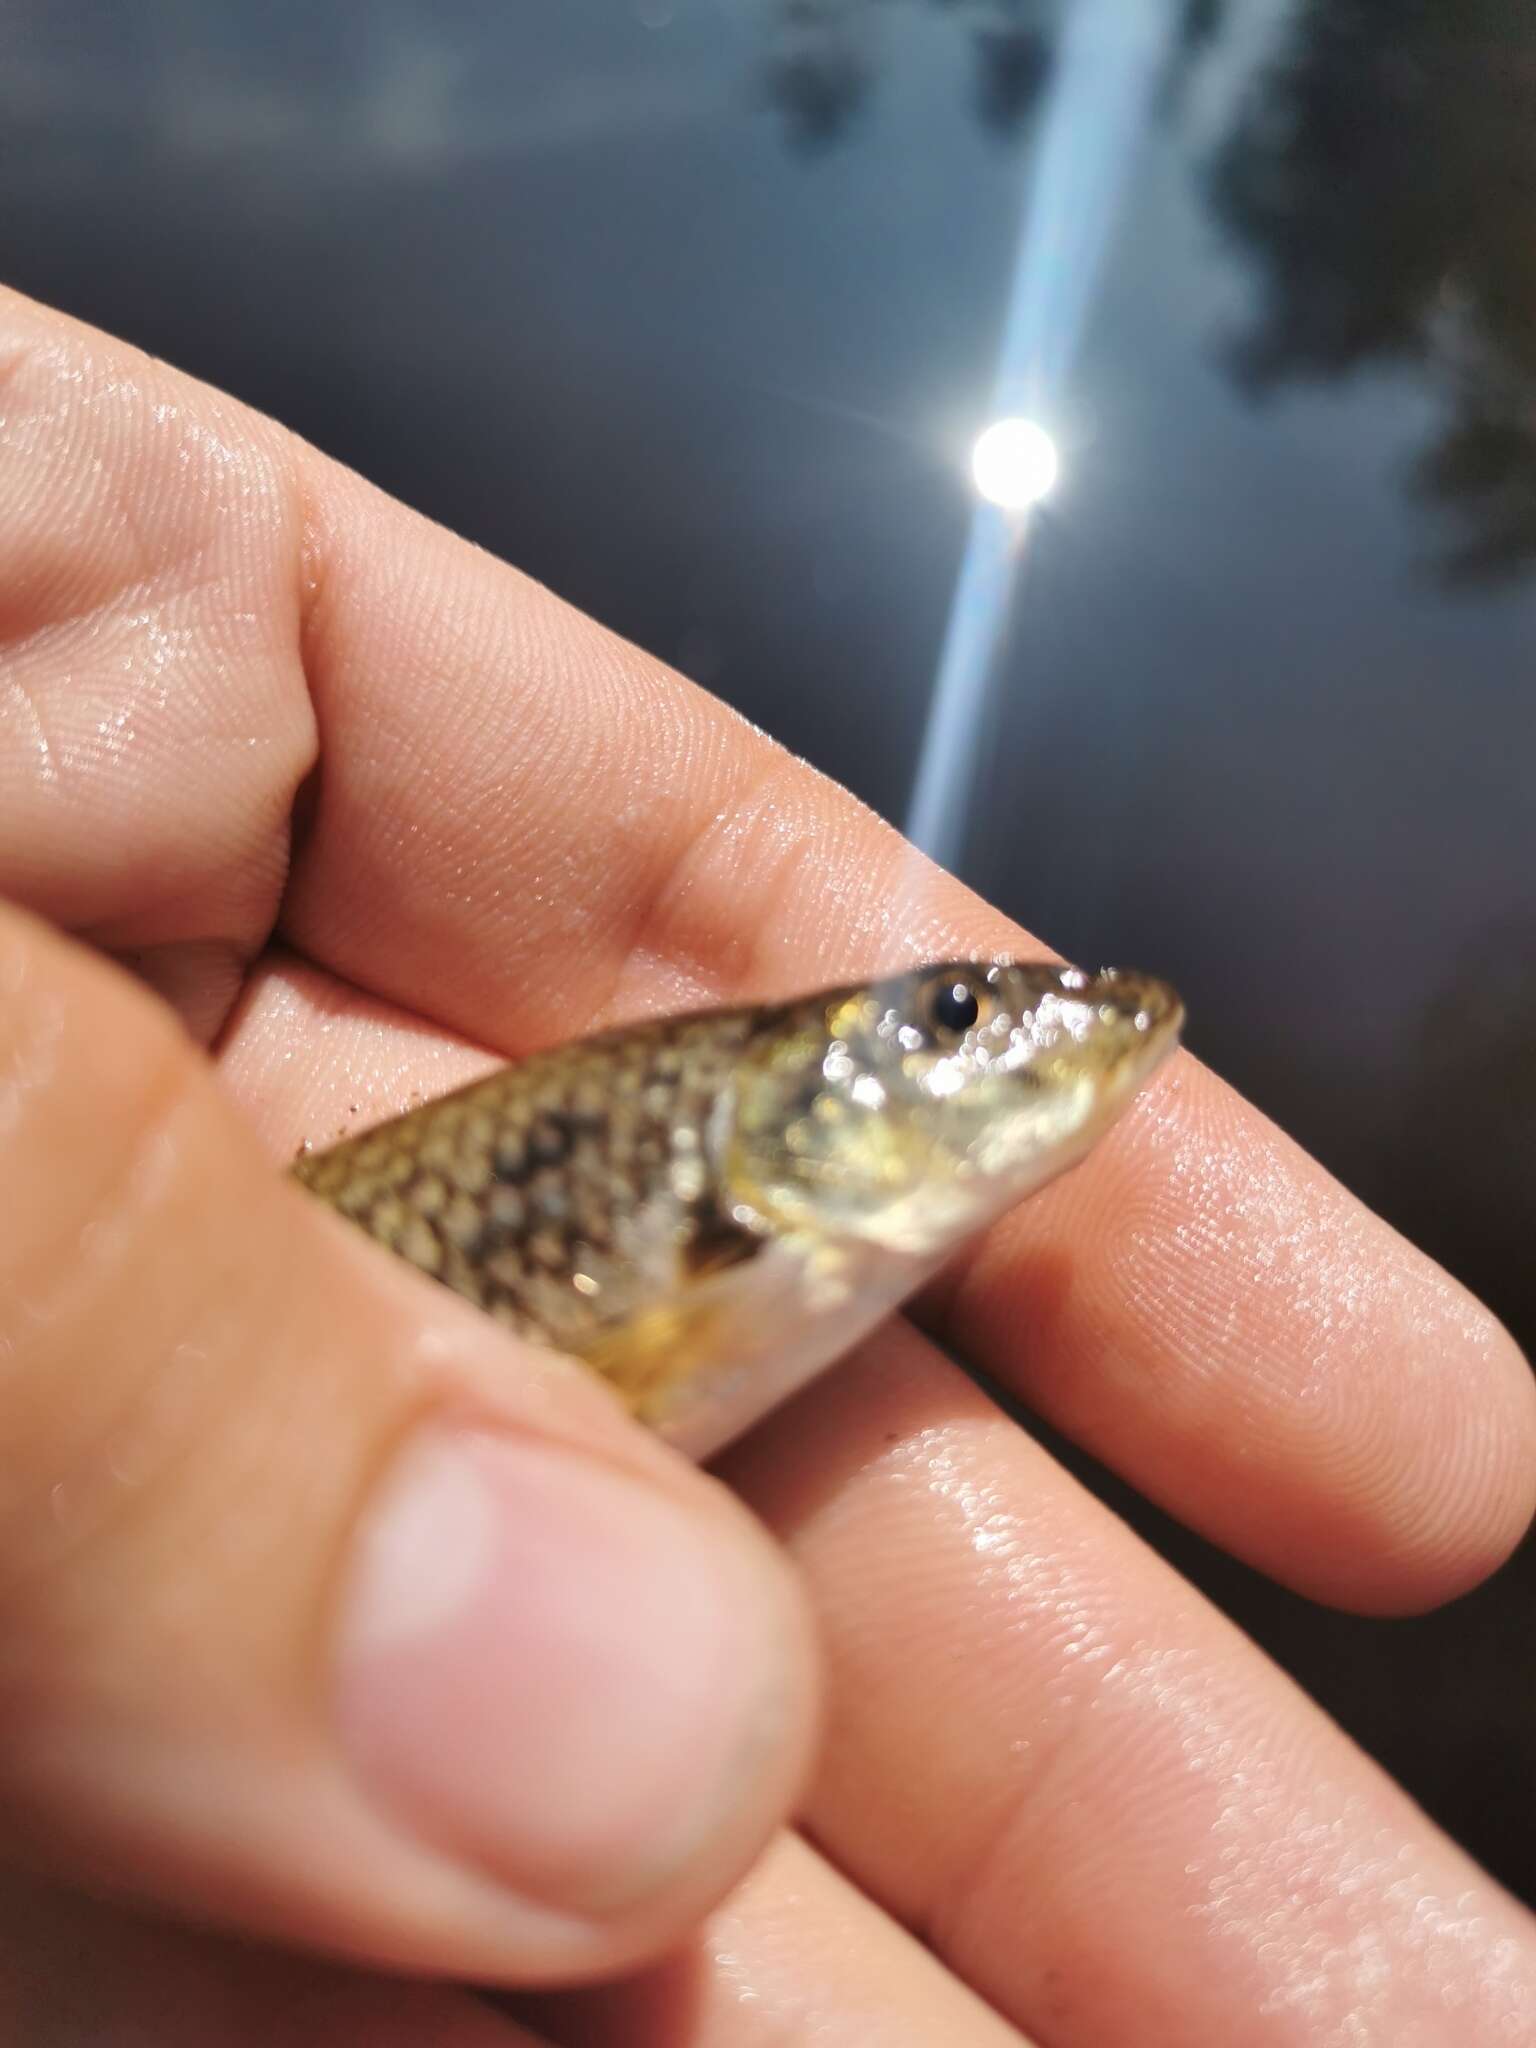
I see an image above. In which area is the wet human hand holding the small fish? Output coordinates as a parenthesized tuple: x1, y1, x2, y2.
(0, 299, 1536, 2048)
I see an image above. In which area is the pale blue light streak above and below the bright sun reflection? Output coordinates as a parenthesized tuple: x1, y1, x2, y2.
(907, 0, 1174, 866)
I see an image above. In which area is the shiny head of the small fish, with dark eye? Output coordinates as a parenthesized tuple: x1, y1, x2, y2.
(723, 961, 1184, 1257)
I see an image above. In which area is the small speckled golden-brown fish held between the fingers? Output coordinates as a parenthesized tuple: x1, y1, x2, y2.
(293, 961, 1184, 1458)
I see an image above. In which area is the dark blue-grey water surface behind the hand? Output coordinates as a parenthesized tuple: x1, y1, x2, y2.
(0, 0, 1536, 1898)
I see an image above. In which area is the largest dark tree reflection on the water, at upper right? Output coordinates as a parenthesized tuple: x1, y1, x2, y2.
(1210, 0, 1536, 584)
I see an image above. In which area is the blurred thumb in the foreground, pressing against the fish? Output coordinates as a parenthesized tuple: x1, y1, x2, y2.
(0, 911, 811, 1982)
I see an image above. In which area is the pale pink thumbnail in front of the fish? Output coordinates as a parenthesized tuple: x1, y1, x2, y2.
(336, 1425, 788, 1913)
